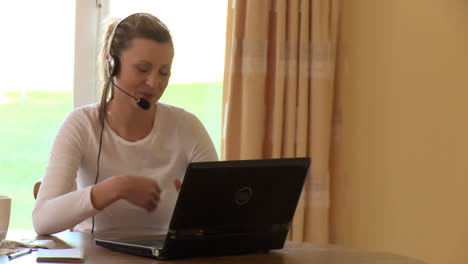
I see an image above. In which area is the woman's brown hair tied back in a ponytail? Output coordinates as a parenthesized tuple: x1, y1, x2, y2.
(99, 13, 173, 118)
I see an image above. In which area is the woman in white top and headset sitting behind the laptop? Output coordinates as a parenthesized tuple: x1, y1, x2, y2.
(33, 13, 218, 234)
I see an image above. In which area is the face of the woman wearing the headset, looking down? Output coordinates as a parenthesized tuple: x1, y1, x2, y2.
(115, 38, 174, 107)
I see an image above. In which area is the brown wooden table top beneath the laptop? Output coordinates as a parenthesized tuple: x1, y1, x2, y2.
(0, 230, 427, 264)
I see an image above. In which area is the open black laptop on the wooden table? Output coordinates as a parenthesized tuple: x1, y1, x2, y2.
(95, 157, 310, 259)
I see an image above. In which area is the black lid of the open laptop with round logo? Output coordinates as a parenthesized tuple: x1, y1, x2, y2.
(169, 158, 310, 235)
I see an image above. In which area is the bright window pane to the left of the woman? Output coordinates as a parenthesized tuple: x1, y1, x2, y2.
(0, 0, 75, 229)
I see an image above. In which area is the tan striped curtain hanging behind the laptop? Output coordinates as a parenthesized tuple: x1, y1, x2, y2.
(221, 0, 342, 243)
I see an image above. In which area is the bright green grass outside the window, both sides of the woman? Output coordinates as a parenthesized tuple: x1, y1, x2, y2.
(0, 82, 222, 229)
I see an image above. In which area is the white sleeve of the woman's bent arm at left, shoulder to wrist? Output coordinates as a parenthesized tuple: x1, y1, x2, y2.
(33, 111, 97, 234)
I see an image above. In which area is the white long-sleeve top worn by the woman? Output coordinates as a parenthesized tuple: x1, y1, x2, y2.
(33, 102, 218, 234)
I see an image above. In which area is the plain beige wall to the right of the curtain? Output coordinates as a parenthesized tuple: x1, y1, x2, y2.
(336, 0, 468, 264)
